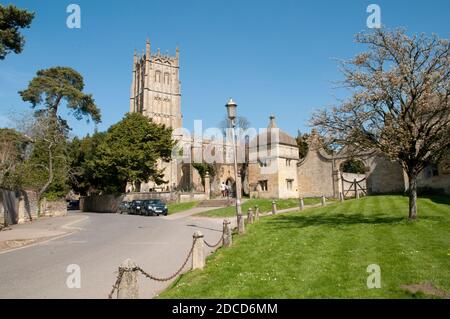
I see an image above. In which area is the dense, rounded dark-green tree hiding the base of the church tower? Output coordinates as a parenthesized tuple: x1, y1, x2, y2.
(86, 113, 175, 193)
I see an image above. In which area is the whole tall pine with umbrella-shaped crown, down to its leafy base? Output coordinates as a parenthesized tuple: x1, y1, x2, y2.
(19, 67, 101, 197)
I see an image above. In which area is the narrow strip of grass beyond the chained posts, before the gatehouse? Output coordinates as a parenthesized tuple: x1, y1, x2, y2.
(198, 198, 320, 217)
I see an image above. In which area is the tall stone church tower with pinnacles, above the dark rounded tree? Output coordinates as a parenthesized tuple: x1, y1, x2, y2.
(130, 39, 183, 129)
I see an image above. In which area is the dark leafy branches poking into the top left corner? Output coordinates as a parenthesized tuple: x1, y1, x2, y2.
(0, 4, 34, 60)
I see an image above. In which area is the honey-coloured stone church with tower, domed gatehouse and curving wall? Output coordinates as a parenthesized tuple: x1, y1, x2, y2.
(127, 40, 450, 198)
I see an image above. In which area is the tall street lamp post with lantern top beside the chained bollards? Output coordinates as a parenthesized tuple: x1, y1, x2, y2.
(225, 98, 245, 234)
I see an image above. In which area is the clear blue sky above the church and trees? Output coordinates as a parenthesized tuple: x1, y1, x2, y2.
(0, 0, 450, 136)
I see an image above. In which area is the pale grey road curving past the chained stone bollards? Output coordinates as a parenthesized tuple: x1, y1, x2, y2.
(0, 212, 222, 298)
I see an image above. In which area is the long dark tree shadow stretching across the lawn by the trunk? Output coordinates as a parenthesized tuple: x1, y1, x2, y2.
(268, 213, 443, 228)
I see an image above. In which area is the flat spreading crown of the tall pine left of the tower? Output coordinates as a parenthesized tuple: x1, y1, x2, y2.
(19, 66, 101, 123)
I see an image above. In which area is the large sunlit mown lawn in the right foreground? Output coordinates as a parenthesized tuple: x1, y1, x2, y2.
(160, 196, 450, 298)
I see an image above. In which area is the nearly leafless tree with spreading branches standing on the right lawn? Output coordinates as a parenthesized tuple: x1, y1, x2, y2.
(311, 29, 450, 219)
